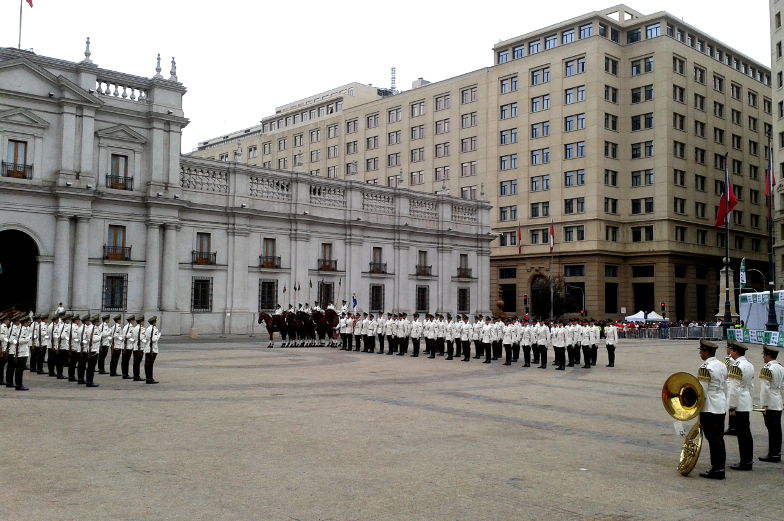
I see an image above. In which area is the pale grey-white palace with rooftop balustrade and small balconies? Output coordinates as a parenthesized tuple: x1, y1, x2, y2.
(0, 41, 493, 334)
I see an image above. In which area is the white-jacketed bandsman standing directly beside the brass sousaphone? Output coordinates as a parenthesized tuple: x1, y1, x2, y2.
(700, 339, 727, 479)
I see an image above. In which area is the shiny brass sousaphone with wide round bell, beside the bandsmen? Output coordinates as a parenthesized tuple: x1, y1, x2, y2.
(662, 373, 705, 476)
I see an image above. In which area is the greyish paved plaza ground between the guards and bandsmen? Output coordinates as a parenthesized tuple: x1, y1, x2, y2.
(0, 338, 784, 521)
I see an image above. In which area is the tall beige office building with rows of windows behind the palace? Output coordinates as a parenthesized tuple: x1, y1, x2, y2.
(194, 1, 772, 320)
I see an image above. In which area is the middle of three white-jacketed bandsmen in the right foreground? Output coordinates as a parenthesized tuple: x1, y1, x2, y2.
(722, 340, 754, 470)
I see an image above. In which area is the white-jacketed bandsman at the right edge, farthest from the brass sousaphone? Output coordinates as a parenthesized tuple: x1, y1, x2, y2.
(758, 346, 784, 463)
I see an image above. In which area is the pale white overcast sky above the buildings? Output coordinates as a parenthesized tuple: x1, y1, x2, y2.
(0, 0, 770, 152)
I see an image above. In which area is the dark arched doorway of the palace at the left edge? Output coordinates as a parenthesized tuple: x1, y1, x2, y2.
(0, 230, 38, 311)
